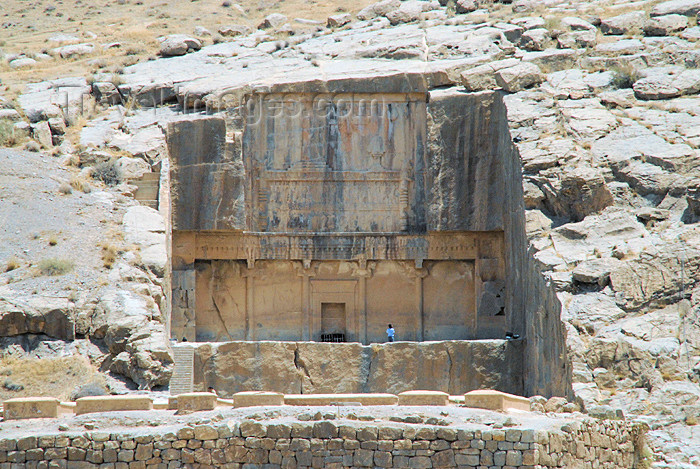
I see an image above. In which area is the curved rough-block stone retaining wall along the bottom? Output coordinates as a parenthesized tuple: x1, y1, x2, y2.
(0, 416, 643, 469)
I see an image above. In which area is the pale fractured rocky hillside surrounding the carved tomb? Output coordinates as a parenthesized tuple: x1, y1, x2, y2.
(0, 0, 700, 468)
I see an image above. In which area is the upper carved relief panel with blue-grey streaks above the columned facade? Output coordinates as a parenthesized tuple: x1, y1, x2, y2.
(243, 93, 426, 233)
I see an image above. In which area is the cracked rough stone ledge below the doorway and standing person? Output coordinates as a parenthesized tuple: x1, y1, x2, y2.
(194, 340, 522, 397)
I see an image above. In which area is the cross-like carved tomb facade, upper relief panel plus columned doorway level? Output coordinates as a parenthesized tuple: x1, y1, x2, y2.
(171, 93, 506, 343)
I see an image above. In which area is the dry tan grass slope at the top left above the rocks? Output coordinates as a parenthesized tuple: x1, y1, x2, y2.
(0, 0, 374, 91)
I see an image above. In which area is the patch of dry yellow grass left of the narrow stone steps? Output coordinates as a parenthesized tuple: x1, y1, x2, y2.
(0, 356, 104, 401)
